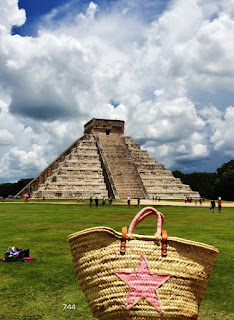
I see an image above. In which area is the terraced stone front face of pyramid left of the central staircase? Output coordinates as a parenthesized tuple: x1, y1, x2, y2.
(33, 135, 108, 199)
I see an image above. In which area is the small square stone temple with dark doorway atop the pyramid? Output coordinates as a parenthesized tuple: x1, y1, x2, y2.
(84, 118, 124, 135)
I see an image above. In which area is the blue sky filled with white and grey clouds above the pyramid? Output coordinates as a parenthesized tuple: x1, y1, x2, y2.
(0, 0, 234, 183)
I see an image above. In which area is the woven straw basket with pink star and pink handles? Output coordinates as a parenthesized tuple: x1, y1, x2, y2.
(68, 207, 218, 320)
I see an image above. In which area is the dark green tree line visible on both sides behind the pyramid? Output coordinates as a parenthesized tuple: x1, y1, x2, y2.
(0, 160, 234, 201)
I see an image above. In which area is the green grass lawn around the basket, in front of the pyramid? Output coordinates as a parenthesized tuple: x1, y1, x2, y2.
(0, 203, 234, 320)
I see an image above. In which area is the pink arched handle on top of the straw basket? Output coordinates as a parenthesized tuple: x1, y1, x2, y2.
(128, 207, 164, 236)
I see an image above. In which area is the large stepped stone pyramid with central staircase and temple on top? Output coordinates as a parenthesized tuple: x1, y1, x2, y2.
(17, 118, 200, 199)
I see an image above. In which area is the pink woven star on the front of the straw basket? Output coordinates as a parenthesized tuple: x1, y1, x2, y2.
(115, 253, 171, 312)
